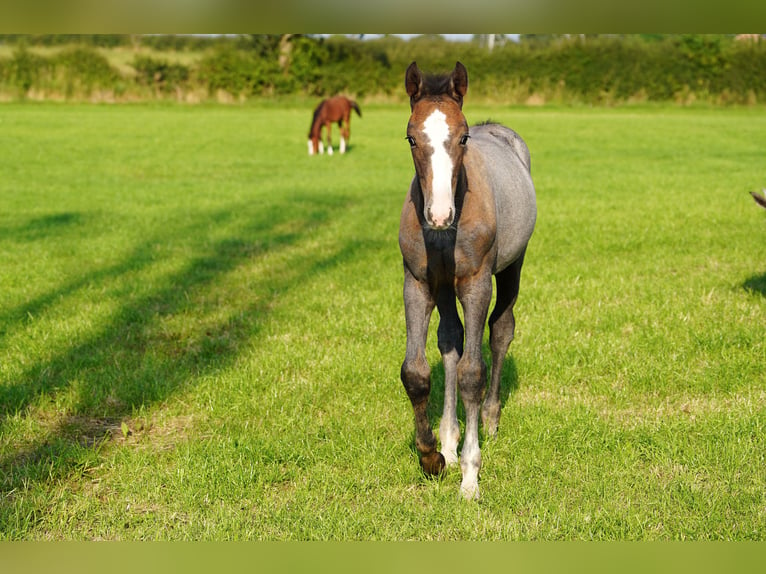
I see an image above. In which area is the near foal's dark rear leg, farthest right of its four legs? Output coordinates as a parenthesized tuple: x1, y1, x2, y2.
(481, 253, 524, 436)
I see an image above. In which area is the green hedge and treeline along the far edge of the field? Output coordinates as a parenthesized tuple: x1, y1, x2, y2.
(0, 34, 766, 104)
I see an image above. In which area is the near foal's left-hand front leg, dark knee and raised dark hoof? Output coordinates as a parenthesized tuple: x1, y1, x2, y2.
(401, 267, 444, 474)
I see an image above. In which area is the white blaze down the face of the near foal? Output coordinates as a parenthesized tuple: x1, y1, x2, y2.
(423, 110, 453, 224)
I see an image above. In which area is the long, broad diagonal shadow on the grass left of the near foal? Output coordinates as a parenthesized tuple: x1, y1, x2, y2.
(0, 192, 378, 493)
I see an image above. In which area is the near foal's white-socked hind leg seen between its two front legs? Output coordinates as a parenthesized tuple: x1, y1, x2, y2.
(436, 286, 463, 465)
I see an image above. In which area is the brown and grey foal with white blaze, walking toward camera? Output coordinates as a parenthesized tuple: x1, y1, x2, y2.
(399, 62, 537, 499)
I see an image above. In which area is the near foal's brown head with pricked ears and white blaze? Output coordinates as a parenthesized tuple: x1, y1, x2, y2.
(405, 62, 469, 229)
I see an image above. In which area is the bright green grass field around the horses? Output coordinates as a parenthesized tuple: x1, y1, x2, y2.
(0, 99, 766, 540)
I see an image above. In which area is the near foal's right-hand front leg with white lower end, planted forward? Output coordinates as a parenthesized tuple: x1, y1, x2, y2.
(457, 266, 492, 499)
